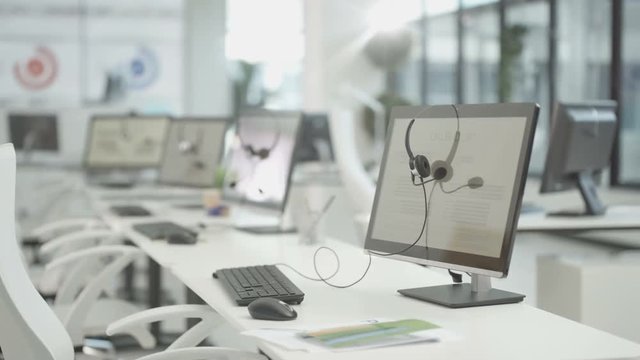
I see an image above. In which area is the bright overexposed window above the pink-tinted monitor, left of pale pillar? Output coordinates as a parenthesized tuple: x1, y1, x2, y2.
(226, 0, 304, 111)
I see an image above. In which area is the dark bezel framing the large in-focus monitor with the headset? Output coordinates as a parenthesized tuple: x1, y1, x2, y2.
(364, 103, 540, 277)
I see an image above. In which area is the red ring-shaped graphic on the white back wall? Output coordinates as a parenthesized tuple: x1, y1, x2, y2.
(13, 46, 58, 91)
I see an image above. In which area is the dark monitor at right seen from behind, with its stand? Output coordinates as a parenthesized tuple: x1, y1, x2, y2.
(540, 100, 618, 215)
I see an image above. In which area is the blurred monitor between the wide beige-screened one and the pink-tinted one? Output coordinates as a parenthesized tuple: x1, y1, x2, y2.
(158, 118, 230, 187)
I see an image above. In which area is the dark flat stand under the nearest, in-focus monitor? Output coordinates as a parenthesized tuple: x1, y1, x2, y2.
(398, 274, 524, 308)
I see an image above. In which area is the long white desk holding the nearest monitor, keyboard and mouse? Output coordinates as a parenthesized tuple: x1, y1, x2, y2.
(95, 200, 640, 360)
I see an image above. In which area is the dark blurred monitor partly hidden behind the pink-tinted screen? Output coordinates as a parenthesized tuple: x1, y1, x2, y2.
(295, 113, 333, 162)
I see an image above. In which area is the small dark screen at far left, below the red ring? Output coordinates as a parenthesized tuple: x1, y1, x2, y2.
(9, 113, 59, 152)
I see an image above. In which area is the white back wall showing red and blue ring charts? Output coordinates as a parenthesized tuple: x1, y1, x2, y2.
(0, 0, 183, 112)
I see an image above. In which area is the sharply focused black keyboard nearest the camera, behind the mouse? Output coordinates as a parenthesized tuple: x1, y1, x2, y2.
(213, 265, 304, 306)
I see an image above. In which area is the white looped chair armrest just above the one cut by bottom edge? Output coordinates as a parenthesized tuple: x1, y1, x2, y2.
(106, 305, 217, 349)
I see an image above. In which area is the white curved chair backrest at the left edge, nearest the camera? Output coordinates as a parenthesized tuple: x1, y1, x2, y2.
(0, 144, 74, 360)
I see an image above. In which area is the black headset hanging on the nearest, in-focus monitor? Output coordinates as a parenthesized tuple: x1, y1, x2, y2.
(404, 104, 484, 193)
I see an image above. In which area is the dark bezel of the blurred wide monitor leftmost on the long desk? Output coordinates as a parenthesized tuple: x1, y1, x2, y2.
(82, 113, 172, 171)
